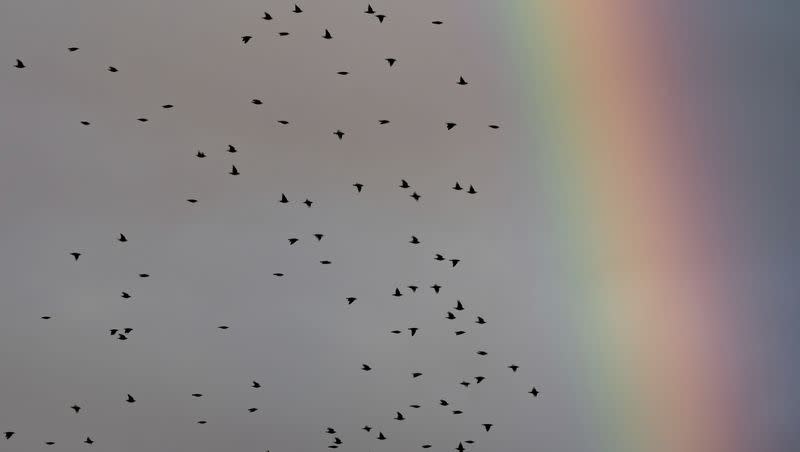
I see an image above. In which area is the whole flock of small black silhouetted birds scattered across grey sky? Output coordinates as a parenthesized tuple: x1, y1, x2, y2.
(4, 4, 539, 452)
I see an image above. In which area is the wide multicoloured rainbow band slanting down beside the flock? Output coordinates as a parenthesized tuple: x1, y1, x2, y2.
(497, 0, 745, 452)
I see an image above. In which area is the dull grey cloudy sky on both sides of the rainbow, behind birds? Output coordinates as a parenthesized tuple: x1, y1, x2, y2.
(0, 0, 800, 452)
